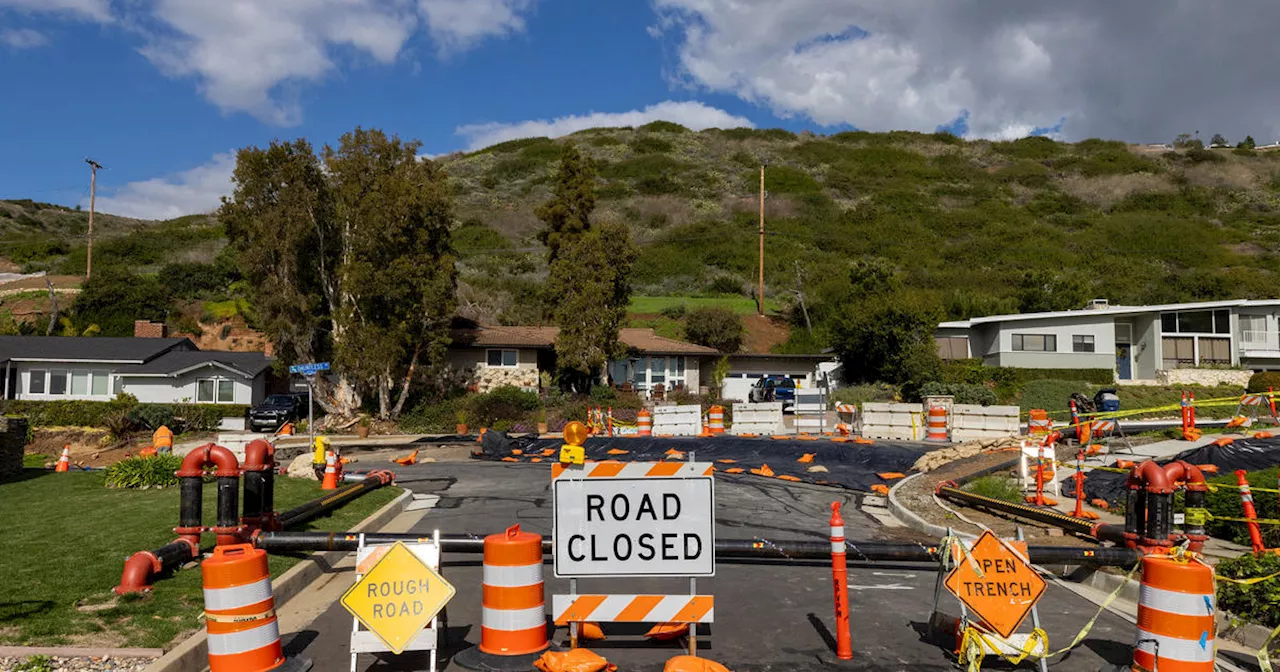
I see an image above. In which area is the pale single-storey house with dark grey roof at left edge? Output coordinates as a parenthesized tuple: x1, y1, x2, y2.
(0, 327, 271, 404)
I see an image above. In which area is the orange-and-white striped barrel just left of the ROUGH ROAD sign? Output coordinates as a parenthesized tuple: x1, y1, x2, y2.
(200, 544, 284, 672)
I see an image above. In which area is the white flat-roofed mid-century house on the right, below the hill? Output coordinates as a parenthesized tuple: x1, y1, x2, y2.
(934, 300, 1280, 381)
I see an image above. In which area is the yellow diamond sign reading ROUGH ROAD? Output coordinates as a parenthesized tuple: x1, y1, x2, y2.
(342, 541, 457, 654)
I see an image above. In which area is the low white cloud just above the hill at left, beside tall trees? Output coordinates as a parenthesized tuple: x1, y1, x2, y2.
(94, 152, 236, 219)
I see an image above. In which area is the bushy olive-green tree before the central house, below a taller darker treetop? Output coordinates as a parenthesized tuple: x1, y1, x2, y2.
(547, 223, 637, 392)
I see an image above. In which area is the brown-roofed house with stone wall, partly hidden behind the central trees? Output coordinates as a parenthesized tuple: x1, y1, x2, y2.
(448, 319, 832, 401)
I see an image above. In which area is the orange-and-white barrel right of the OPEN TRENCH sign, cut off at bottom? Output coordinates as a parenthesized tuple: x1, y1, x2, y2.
(1133, 556, 1216, 672)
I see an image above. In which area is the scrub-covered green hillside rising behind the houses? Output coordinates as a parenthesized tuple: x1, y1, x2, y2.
(0, 129, 1280, 353)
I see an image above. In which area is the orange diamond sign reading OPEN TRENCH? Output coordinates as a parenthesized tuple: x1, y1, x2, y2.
(946, 530, 1047, 639)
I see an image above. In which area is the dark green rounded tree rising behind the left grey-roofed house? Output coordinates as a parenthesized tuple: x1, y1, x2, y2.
(72, 266, 173, 337)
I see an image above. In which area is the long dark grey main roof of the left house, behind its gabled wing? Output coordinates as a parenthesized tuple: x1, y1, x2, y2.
(0, 335, 196, 364)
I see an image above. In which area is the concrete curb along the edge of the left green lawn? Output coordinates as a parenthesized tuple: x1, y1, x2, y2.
(146, 490, 413, 672)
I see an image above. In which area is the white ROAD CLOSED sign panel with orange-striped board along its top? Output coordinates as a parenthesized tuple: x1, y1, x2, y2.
(552, 462, 716, 579)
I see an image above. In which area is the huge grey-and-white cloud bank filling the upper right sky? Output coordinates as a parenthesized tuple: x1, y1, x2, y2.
(654, 0, 1280, 141)
